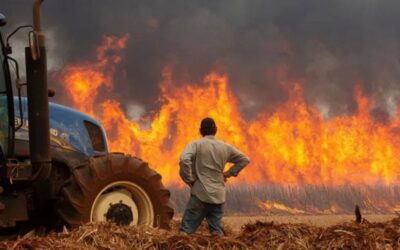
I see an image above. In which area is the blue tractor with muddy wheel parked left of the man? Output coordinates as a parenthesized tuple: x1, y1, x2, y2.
(0, 0, 174, 233)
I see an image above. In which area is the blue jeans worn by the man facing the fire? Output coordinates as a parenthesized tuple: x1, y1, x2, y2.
(179, 195, 224, 235)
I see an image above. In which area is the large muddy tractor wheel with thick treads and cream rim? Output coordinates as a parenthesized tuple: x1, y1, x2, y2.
(56, 154, 174, 229)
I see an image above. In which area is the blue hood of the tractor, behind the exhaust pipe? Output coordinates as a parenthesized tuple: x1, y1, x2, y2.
(14, 97, 108, 156)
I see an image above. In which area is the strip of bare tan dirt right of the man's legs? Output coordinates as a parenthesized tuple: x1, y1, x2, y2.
(223, 214, 397, 232)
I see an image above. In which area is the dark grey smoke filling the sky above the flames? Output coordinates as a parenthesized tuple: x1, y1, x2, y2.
(1, 0, 400, 119)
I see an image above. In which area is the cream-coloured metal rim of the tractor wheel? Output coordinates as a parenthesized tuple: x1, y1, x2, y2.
(90, 181, 154, 226)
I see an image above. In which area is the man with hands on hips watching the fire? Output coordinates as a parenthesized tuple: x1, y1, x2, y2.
(179, 118, 250, 235)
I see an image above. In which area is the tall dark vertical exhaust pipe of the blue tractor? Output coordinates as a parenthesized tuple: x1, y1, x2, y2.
(25, 0, 51, 181)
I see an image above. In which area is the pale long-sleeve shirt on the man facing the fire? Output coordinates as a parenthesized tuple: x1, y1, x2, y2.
(179, 136, 250, 204)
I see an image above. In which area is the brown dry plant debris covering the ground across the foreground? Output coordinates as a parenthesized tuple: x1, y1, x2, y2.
(0, 217, 400, 250)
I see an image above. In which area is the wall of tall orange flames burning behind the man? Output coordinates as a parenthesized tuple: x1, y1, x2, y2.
(57, 35, 400, 188)
